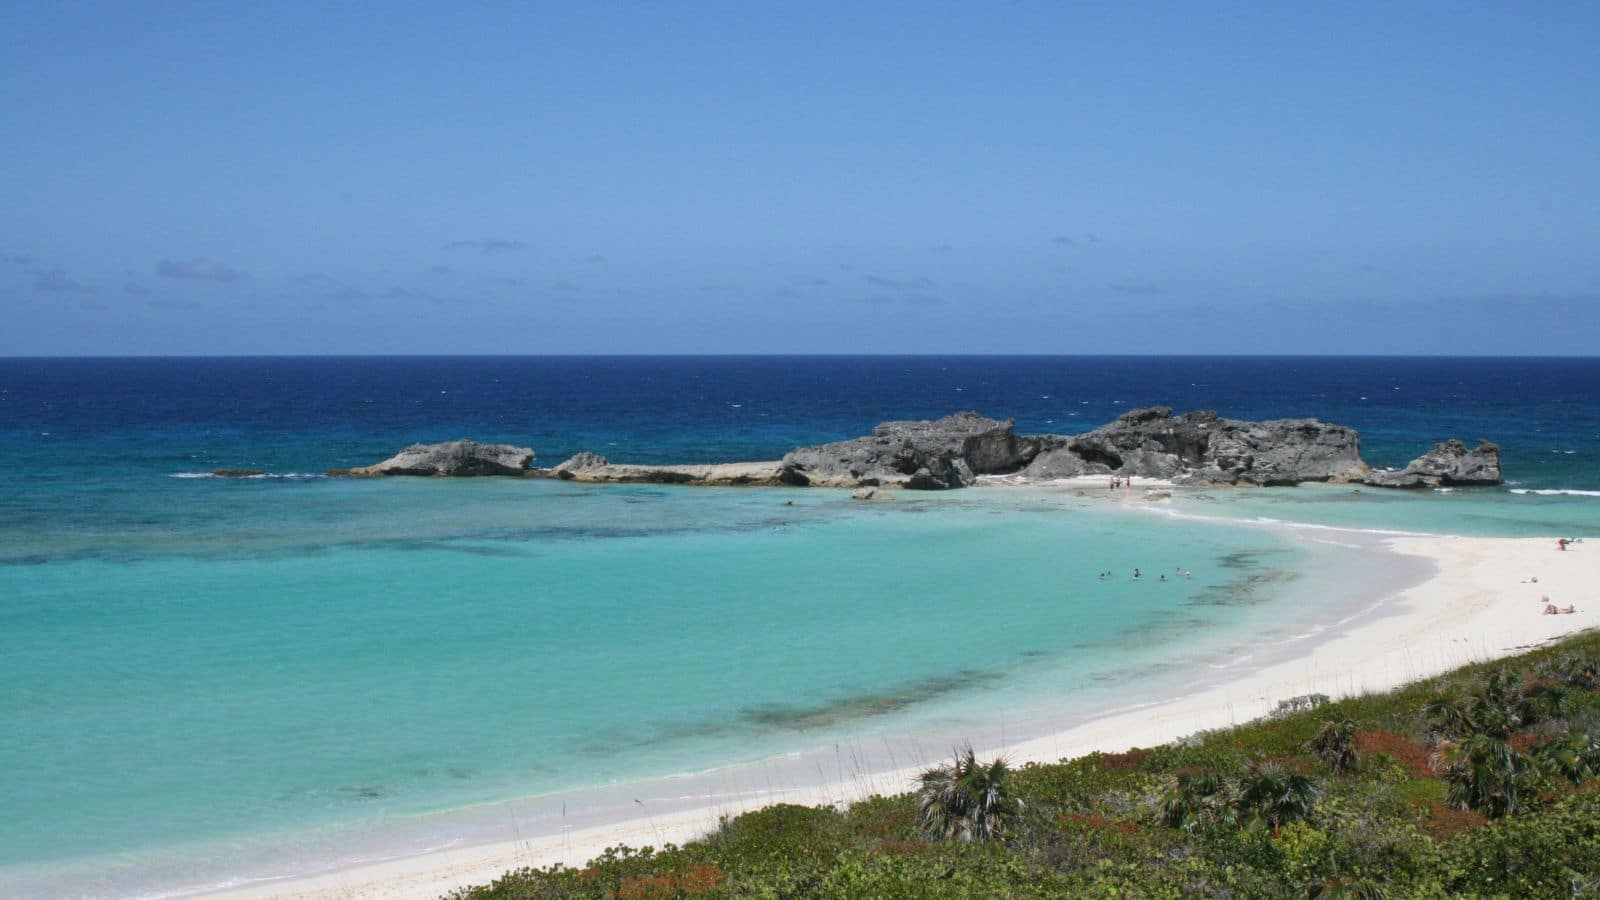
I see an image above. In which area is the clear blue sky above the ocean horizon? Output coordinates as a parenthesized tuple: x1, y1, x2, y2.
(0, 0, 1600, 356)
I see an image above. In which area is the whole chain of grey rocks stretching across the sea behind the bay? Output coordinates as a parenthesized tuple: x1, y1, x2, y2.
(330, 407, 1501, 490)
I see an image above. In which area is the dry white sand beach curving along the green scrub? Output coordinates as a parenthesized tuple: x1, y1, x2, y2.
(200, 522, 1600, 898)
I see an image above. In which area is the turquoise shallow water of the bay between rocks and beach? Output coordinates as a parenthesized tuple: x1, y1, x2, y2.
(0, 479, 1427, 892)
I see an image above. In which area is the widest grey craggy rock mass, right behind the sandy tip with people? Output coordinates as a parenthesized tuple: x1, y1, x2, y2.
(1022, 407, 1368, 485)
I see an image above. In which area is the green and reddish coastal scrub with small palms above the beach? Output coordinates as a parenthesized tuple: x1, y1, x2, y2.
(451, 633, 1600, 900)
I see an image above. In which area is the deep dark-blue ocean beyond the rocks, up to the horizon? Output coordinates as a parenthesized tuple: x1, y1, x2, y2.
(0, 357, 1600, 480)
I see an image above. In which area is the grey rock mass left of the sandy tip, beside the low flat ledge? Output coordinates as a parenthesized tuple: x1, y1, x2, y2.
(779, 412, 1048, 490)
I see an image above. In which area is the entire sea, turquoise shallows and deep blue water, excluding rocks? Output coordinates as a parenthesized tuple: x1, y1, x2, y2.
(0, 357, 1600, 897)
